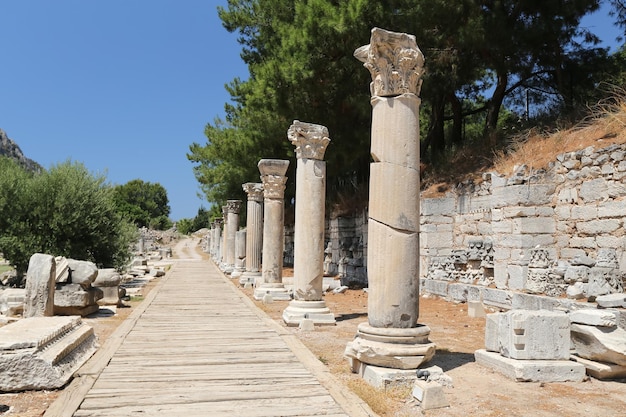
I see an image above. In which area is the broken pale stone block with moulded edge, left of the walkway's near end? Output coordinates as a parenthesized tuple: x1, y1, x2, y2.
(0, 317, 96, 392)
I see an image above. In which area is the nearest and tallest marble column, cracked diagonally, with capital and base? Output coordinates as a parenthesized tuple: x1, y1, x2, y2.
(345, 28, 435, 375)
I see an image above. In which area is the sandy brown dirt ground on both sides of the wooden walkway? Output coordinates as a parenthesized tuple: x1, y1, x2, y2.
(0, 262, 626, 417)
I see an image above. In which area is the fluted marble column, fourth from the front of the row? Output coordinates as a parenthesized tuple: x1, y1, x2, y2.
(239, 182, 263, 285)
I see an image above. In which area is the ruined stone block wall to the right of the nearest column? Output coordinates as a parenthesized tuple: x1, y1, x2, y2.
(420, 145, 626, 304)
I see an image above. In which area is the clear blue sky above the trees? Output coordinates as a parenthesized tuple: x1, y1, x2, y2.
(0, 0, 619, 220)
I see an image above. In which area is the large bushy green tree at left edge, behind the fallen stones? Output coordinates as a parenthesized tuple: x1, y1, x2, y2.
(0, 158, 136, 274)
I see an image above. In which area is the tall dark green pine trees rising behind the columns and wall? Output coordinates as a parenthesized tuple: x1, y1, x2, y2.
(188, 0, 610, 213)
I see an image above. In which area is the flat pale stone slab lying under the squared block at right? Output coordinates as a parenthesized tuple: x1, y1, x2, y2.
(474, 349, 585, 382)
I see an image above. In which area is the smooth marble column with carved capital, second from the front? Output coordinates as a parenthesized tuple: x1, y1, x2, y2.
(283, 120, 335, 326)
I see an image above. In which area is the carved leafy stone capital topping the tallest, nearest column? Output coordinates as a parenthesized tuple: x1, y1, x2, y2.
(354, 28, 424, 97)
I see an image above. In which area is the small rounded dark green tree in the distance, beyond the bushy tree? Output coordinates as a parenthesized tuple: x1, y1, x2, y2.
(114, 179, 172, 230)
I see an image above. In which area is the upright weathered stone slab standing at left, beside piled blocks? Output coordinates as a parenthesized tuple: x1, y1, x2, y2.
(24, 253, 56, 318)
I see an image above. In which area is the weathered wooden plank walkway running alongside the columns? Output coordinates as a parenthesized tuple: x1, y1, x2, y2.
(45, 260, 374, 417)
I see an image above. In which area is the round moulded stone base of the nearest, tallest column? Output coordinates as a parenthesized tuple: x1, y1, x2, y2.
(344, 323, 436, 373)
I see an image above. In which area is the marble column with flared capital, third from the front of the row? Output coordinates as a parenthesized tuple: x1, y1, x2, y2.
(254, 159, 291, 300)
